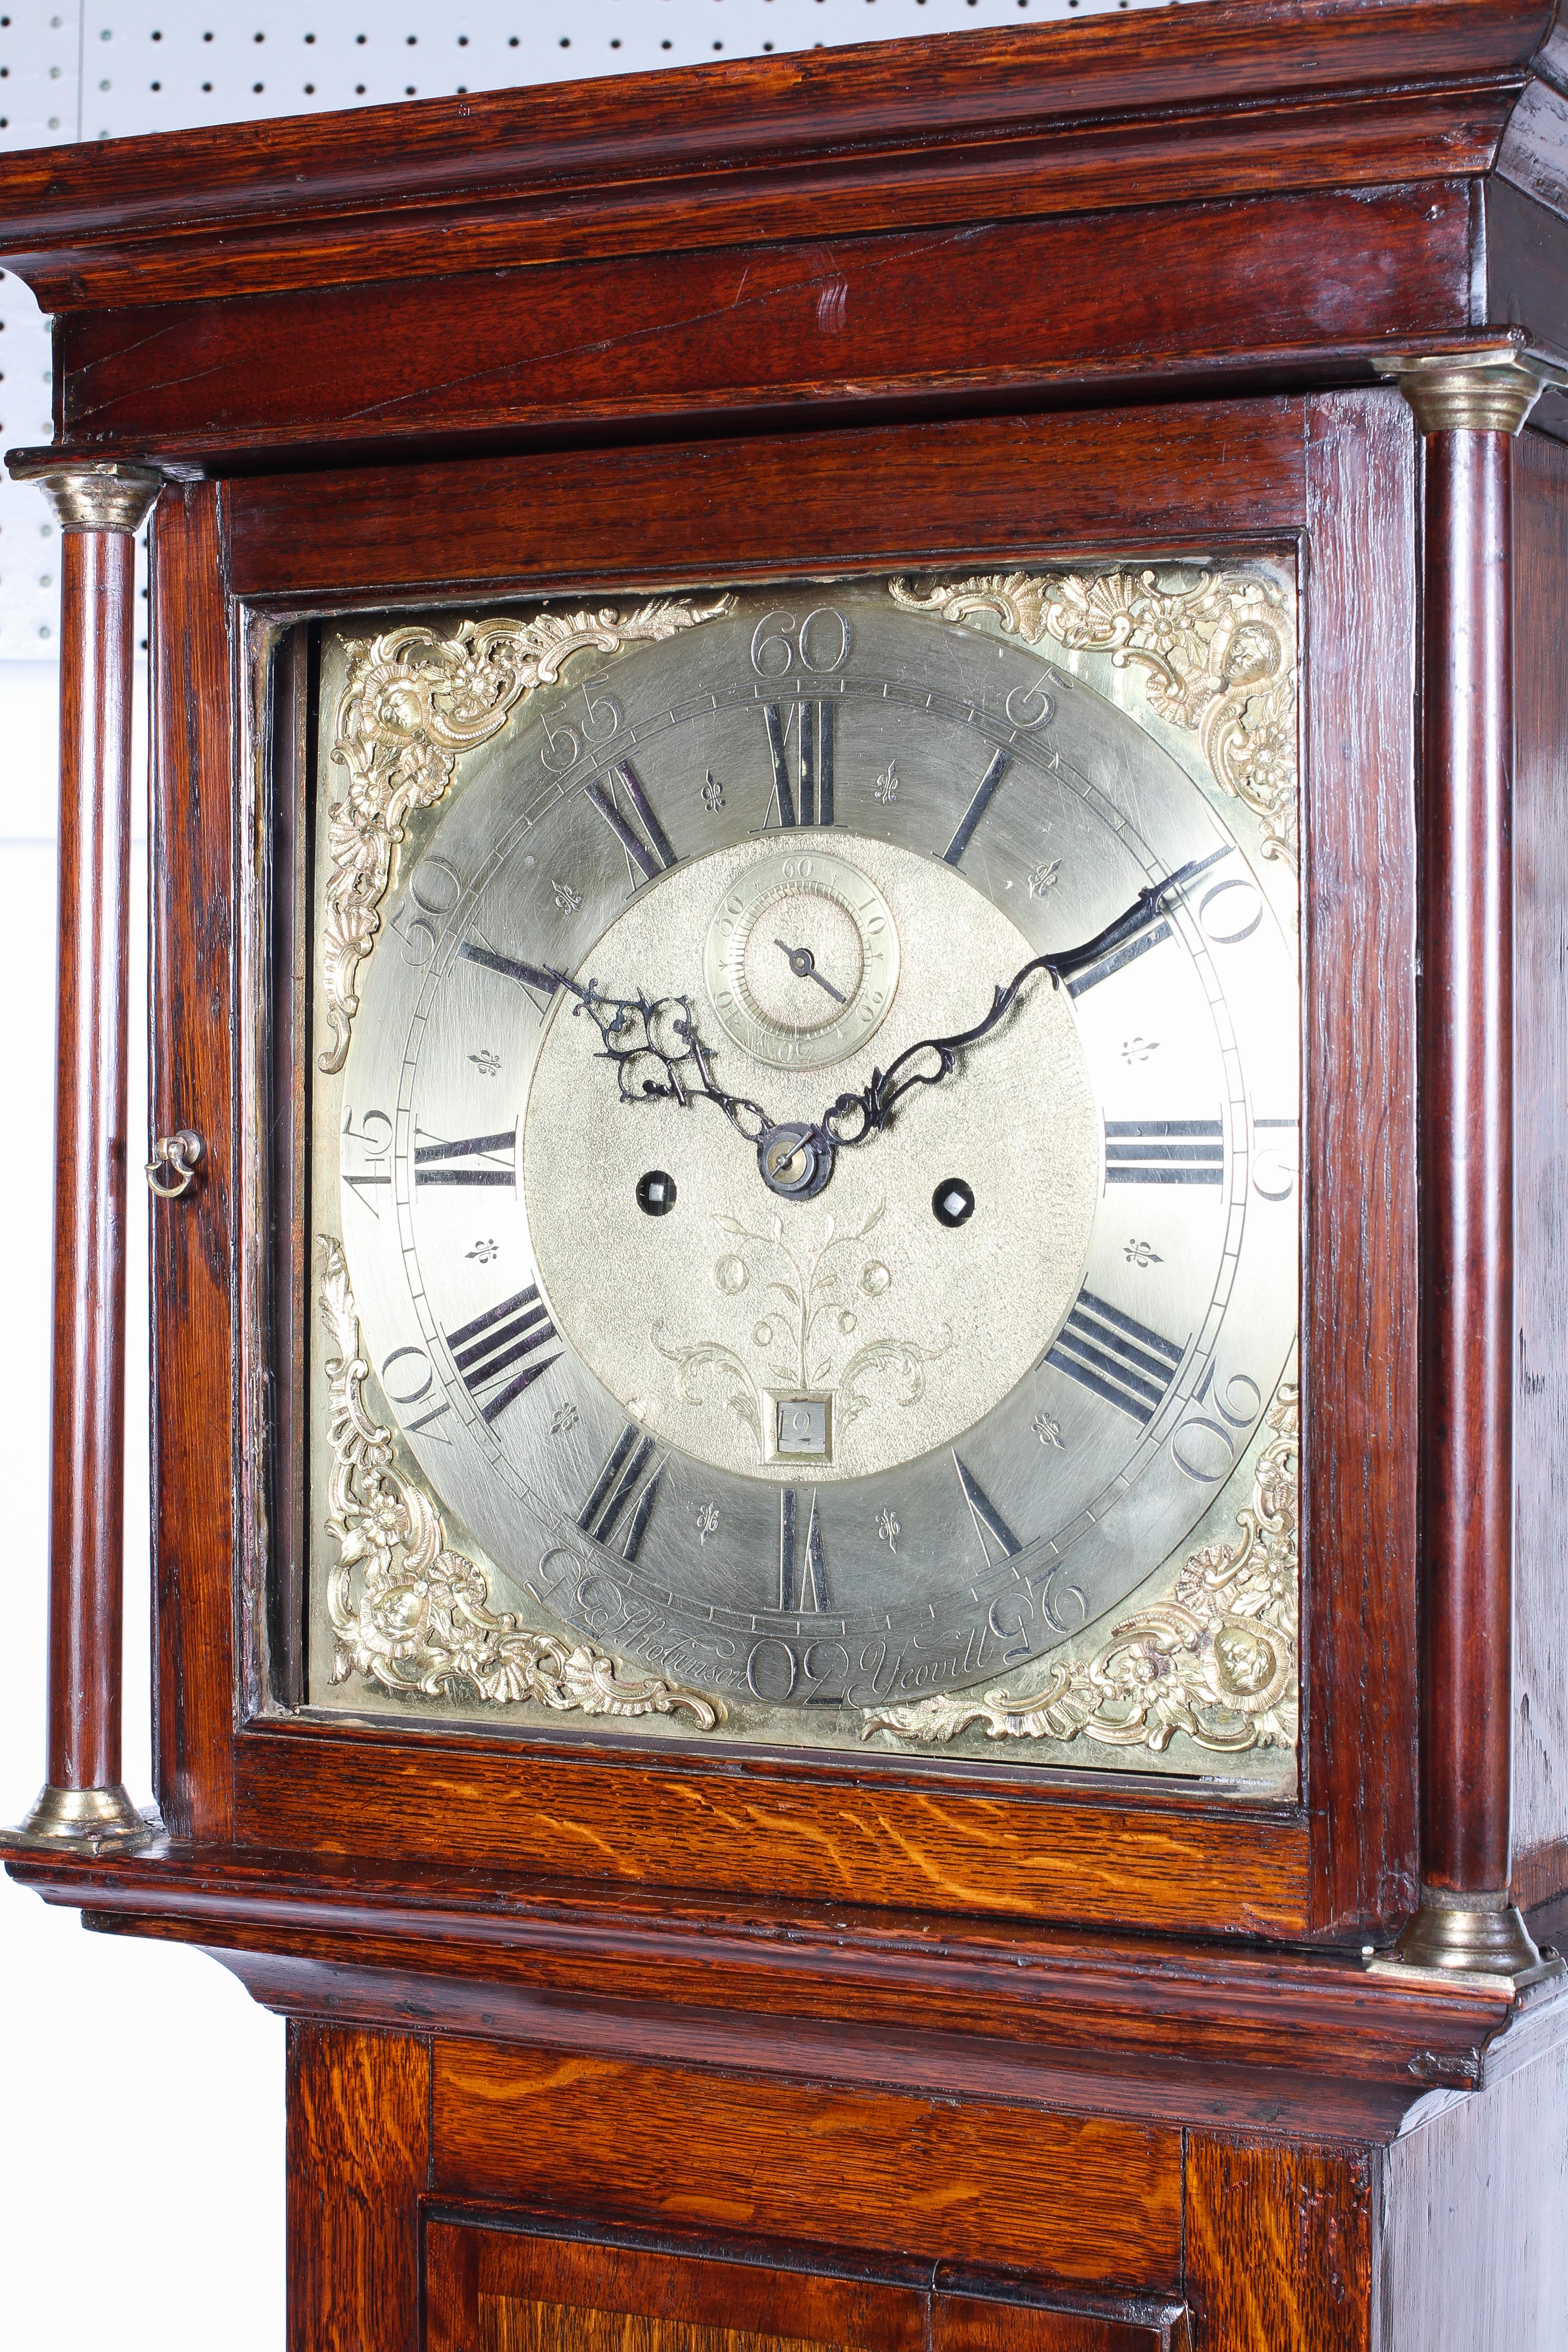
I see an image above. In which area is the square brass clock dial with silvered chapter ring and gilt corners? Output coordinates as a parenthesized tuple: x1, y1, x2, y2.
(308, 564, 1300, 1797)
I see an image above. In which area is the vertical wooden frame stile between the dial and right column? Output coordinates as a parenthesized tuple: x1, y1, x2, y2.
(1303, 393, 1417, 1929)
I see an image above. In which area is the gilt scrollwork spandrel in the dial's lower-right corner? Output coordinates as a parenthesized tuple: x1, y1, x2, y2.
(865, 1381, 1300, 1754)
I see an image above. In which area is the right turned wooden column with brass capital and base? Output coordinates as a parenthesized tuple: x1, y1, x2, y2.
(1394, 348, 1542, 1978)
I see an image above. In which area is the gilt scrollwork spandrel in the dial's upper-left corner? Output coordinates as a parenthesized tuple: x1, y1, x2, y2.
(320, 598, 731, 1070)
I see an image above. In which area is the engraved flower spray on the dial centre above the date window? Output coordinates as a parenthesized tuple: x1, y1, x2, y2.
(651, 1202, 952, 1451)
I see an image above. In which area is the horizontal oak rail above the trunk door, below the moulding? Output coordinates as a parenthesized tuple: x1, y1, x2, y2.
(432, 2042, 1182, 2288)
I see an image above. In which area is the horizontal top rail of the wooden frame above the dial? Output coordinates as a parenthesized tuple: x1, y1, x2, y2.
(225, 397, 1307, 604)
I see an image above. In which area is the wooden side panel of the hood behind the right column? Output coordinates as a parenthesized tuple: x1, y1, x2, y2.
(1514, 418, 1568, 1903)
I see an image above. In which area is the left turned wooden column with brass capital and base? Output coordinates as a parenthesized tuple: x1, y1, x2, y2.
(10, 451, 160, 1846)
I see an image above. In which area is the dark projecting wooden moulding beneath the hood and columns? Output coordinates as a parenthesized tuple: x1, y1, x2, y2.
(0, 1846, 1514, 2107)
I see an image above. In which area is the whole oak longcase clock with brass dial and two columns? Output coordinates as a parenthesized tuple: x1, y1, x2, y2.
(0, 0, 1568, 2352)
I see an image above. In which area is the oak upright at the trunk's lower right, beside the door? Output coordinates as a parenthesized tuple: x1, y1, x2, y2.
(1187, 2131, 1372, 2352)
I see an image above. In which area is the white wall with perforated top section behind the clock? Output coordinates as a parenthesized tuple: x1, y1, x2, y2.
(0, 0, 1194, 2352)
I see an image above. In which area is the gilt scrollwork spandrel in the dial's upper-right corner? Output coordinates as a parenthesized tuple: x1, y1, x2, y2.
(889, 572, 1298, 872)
